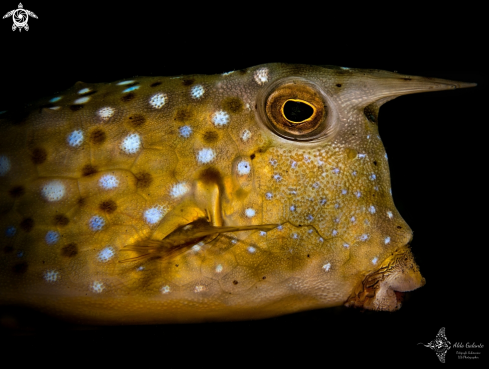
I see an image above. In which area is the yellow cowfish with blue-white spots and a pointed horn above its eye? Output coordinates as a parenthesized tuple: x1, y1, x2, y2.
(0, 64, 475, 324)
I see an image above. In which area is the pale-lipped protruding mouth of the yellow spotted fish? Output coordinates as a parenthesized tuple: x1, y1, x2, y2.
(345, 245, 426, 311)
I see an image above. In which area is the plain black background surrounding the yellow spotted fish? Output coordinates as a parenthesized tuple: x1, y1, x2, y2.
(0, 1, 489, 368)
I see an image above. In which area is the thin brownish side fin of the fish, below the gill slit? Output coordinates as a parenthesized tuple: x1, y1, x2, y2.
(119, 219, 272, 263)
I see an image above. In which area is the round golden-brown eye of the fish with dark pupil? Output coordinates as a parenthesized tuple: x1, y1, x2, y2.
(262, 78, 328, 141)
